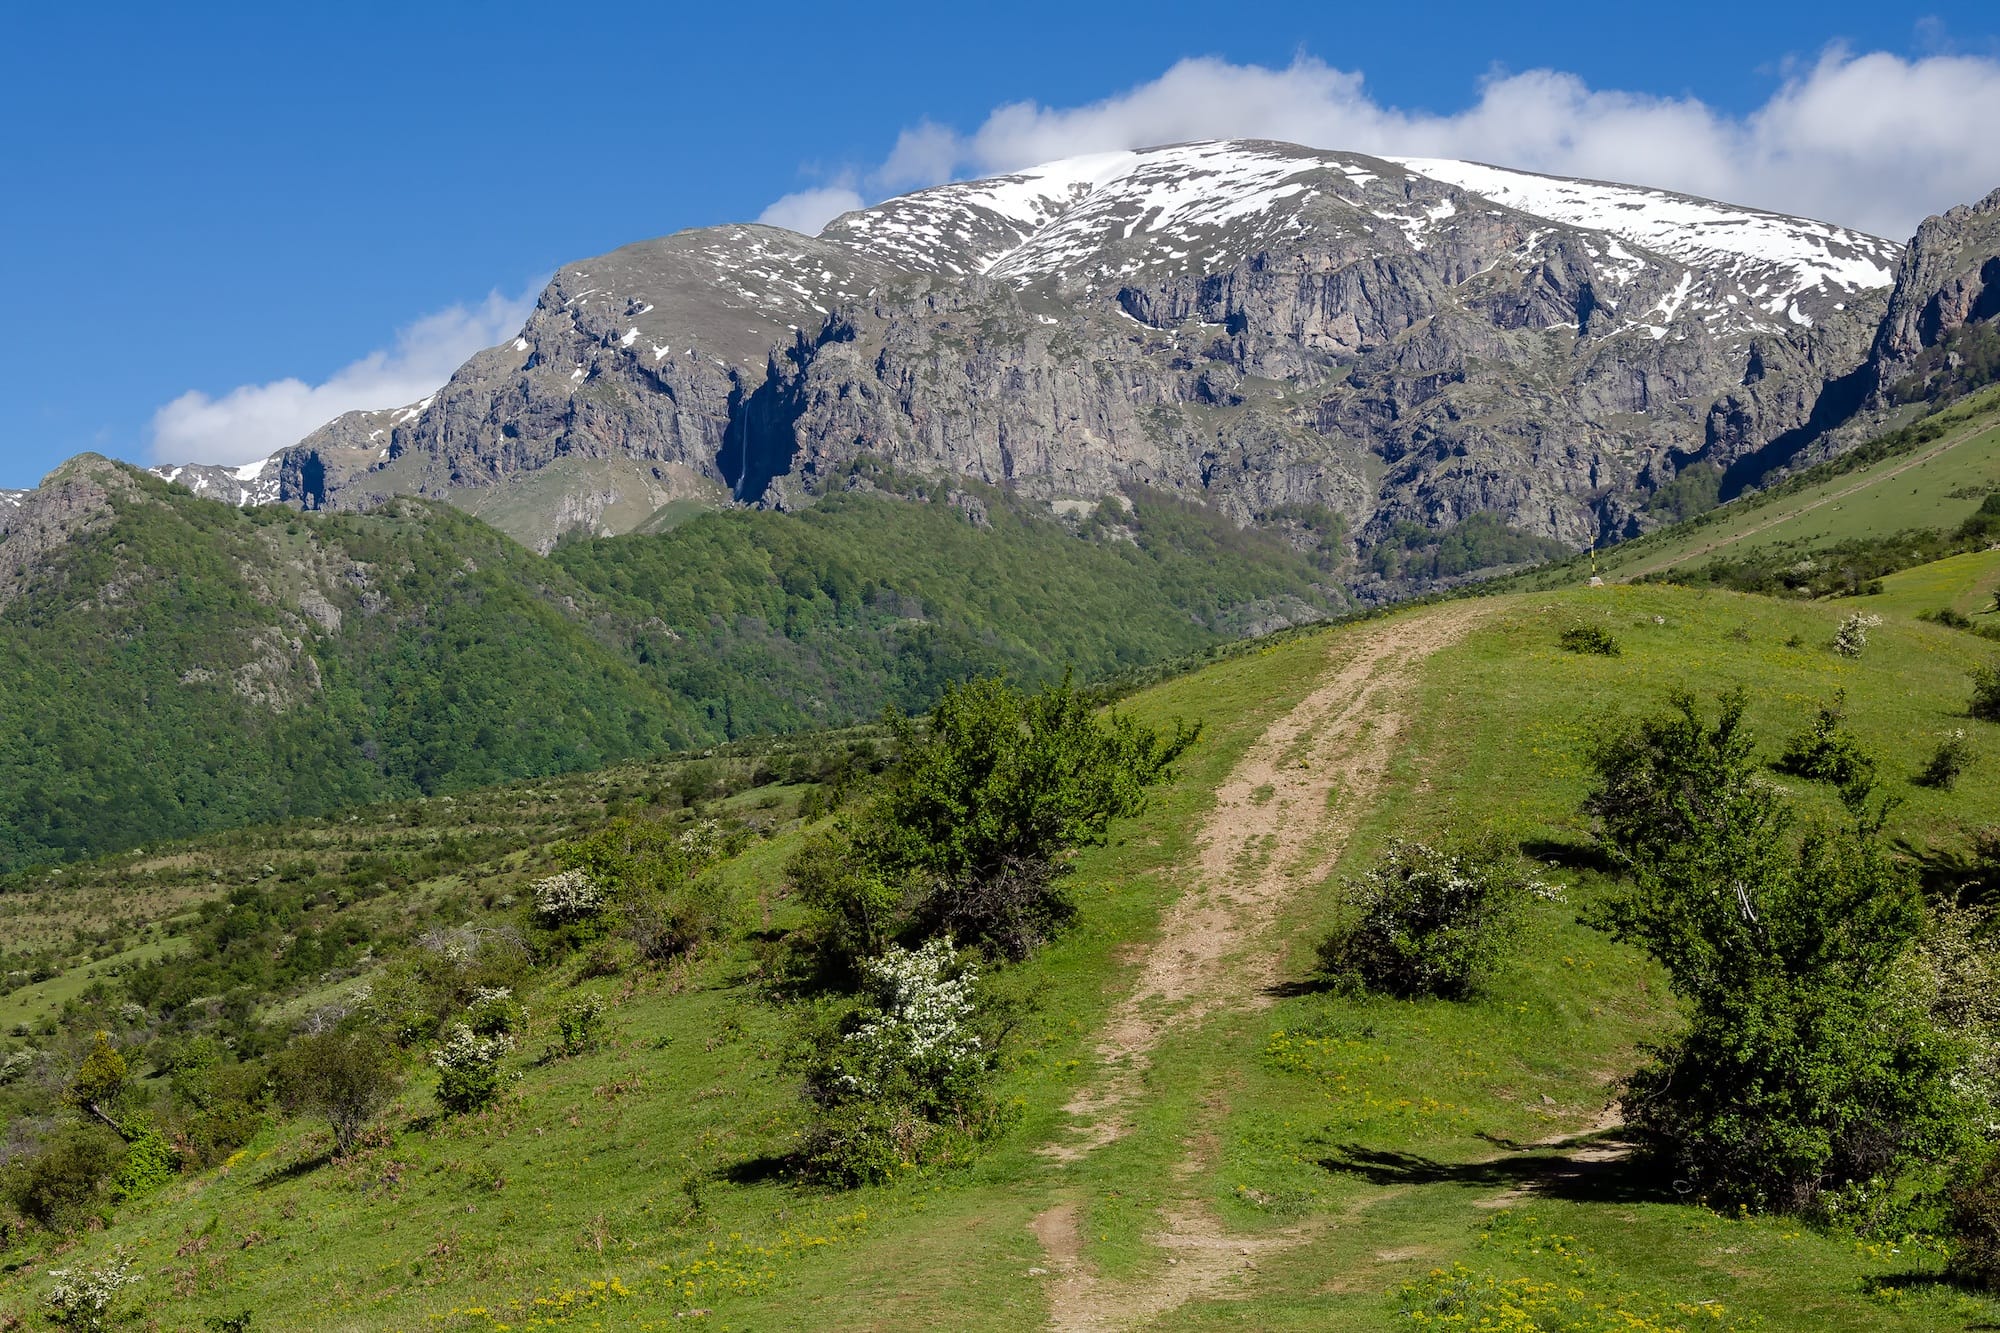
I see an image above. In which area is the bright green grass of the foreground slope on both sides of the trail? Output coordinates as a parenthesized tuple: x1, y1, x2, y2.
(0, 556, 2000, 1331)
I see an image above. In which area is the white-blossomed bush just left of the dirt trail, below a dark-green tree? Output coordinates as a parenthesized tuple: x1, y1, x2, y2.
(840, 937, 986, 1097)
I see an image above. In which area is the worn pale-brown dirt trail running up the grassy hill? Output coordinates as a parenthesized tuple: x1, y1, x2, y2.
(1034, 602, 1488, 1333)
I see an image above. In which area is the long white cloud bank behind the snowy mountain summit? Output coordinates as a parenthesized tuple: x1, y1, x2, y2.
(764, 46, 2000, 240)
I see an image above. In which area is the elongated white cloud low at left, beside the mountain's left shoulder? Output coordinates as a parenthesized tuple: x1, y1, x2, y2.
(152, 282, 542, 462)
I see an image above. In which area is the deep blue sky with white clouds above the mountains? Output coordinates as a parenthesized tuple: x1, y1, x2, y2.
(0, 0, 2000, 486)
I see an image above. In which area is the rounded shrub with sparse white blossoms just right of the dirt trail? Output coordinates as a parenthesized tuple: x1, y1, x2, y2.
(1318, 841, 1550, 999)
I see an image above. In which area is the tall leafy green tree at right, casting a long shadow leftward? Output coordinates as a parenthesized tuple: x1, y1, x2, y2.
(1586, 695, 1966, 1211)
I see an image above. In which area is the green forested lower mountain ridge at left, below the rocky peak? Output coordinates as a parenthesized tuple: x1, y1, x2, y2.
(0, 454, 1346, 871)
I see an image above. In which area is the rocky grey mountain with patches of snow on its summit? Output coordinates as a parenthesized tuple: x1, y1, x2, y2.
(242, 140, 1928, 556)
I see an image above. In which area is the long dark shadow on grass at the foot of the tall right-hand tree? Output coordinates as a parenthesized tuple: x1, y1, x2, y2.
(1318, 1135, 1684, 1203)
